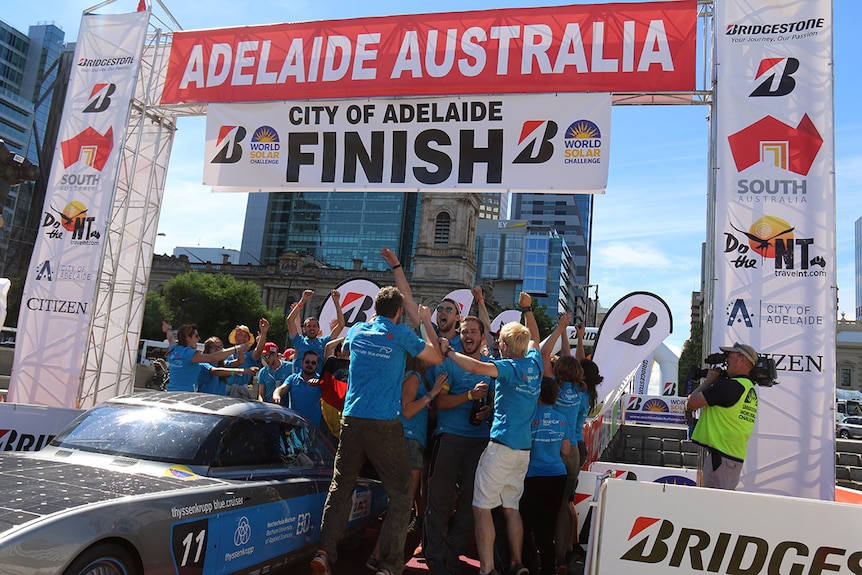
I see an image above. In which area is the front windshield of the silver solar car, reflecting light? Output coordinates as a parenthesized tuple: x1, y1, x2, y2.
(51, 405, 222, 465)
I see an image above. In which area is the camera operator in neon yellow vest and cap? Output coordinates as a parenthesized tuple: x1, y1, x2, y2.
(686, 343, 757, 490)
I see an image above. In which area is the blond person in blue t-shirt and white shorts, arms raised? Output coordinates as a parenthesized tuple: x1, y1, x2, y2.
(440, 292, 542, 575)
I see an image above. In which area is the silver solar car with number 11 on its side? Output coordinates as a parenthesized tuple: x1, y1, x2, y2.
(0, 392, 385, 575)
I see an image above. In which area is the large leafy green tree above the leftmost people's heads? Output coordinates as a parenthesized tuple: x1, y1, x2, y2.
(162, 271, 266, 345)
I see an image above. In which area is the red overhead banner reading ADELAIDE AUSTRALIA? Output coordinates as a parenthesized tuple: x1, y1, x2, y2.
(162, 0, 697, 104)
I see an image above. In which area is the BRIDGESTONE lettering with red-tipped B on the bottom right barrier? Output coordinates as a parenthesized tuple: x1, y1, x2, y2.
(620, 517, 862, 575)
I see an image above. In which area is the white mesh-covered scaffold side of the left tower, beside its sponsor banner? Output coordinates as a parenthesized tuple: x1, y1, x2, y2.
(78, 31, 176, 408)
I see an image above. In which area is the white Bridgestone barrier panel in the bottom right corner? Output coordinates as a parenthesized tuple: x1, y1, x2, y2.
(586, 480, 862, 575)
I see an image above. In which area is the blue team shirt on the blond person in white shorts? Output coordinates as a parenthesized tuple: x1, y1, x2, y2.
(491, 348, 542, 449)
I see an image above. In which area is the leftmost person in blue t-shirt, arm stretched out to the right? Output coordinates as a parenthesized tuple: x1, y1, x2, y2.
(162, 322, 248, 391)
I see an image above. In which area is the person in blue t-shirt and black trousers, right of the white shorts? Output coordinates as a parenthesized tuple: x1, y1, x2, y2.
(521, 378, 574, 575)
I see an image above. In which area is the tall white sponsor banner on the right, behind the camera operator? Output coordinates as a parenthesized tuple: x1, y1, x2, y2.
(710, 0, 836, 498)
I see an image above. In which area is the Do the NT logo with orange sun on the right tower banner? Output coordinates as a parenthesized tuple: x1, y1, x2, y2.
(724, 216, 826, 278)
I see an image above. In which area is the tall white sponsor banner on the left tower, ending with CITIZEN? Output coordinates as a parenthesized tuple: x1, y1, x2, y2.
(8, 12, 149, 407)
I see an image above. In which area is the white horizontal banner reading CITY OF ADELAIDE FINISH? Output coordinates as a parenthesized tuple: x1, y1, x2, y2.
(204, 94, 611, 193)
